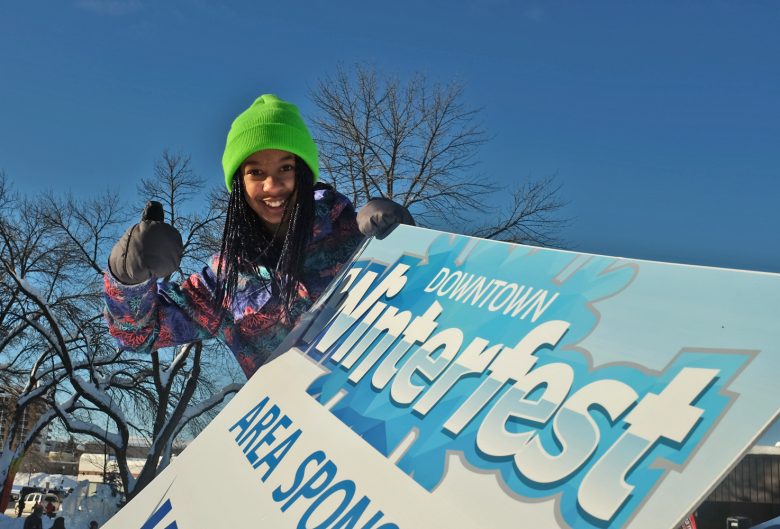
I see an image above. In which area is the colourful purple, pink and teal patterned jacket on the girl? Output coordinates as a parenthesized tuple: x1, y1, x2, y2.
(104, 189, 363, 378)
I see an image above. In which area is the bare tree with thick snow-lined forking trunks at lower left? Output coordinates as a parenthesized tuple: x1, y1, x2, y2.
(0, 251, 241, 500)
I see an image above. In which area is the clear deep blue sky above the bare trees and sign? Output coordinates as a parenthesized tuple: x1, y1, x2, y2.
(0, 0, 780, 442)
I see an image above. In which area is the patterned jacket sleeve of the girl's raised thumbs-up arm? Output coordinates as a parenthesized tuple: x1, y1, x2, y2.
(104, 260, 232, 351)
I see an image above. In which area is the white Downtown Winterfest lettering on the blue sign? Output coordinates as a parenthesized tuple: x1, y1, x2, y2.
(314, 263, 719, 521)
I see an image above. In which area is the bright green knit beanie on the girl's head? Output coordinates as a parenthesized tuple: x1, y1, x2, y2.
(222, 94, 320, 191)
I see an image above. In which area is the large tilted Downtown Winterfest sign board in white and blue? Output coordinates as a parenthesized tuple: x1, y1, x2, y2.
(108, 226, 780, 529)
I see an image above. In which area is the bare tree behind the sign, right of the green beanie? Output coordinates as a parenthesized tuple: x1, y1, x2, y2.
(311, 66, 564, 245)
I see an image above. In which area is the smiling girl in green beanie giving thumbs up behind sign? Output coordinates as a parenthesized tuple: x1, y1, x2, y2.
(104, 95, 413, 377)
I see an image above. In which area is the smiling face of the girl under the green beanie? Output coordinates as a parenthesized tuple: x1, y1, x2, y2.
(240, 149, 296, 233)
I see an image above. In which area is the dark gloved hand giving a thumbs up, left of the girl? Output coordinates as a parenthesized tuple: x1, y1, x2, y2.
(108, 201, 184, 285)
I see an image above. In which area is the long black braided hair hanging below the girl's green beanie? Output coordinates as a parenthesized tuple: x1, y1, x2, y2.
(214, 156, 314, 319)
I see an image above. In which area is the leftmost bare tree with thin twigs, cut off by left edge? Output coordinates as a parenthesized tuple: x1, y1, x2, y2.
(0, 183, 85, 508)
